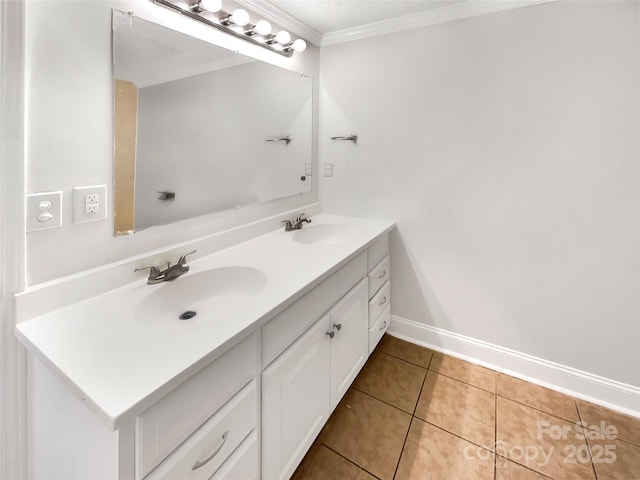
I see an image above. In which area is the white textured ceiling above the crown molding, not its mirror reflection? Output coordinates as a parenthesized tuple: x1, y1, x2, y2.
(269, 0, 463, 35)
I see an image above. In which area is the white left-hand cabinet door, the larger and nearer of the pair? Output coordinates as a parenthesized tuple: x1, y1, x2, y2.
(262, 315, 330, 480)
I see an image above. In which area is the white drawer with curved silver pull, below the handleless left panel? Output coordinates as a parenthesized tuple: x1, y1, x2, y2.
(147, 380, 257, 480)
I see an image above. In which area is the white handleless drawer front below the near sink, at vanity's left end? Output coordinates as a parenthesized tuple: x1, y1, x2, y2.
(136, 334, 257, 478)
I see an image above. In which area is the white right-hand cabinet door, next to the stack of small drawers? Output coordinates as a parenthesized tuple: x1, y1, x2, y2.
(329, 278, 369, 410)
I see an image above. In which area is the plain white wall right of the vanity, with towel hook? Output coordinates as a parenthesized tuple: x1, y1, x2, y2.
(319, 1, 640, 386)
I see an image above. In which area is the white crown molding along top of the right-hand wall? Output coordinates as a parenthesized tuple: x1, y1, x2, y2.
(320, 0, 556, 47)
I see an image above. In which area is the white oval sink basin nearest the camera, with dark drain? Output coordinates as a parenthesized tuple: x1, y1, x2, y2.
(135, 266, 267, 328)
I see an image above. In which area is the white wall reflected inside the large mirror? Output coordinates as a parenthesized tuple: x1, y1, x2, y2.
(135, 62, 313, 229)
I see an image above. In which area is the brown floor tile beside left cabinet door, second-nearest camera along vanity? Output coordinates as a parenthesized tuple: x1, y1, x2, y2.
(319, 389, 411, 480)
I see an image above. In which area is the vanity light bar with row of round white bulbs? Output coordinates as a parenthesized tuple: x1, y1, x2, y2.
(153, 0, 307, 57)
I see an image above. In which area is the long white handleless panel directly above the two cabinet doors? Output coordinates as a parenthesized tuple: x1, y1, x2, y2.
(262, 252, 367, 366)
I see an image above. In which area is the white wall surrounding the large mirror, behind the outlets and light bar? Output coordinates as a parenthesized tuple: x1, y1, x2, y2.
(25, 0, 318, 284)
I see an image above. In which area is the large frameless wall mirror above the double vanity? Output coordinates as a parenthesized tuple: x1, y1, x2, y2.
(112, 10, 312, 235)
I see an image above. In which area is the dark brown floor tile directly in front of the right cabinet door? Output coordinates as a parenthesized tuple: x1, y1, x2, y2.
(353, 351, 427, 414)
